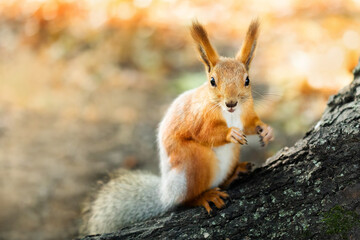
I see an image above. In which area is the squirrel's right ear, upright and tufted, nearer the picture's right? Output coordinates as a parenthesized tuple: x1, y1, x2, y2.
(236, 19, 260, 70)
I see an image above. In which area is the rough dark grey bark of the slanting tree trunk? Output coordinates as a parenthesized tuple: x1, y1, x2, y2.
(79, 63, 360, 240)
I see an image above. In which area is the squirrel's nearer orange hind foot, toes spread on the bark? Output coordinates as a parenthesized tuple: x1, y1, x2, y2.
(186, 188, 229, 214)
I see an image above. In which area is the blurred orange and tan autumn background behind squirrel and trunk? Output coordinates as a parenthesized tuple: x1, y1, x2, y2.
(0, 0, 360, 240)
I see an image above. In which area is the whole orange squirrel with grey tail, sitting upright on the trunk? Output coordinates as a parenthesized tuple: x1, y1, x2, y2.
(82, 20, 273, 234)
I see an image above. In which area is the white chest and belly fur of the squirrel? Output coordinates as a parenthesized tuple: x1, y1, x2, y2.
(211, 107, 243, 188)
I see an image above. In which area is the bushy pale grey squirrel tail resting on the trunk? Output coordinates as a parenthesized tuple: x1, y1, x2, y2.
(80, 170, 167, 235)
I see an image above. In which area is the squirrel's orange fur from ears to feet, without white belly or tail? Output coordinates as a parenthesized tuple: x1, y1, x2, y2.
(160, 21, 267, 211)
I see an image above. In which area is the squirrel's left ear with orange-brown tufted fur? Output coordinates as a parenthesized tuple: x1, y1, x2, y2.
(190, 21, 219, 72)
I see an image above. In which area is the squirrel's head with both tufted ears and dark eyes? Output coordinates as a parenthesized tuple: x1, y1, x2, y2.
(191, 20, 259, 112)
